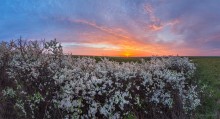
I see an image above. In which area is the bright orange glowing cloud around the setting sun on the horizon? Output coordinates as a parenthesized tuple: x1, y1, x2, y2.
(64, 30, 180, 56)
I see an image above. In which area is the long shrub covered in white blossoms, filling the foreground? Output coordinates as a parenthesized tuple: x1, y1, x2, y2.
(0, 40, 200, 118)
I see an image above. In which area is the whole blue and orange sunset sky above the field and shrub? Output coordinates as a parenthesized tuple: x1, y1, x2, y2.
(0, 0, 220, 56)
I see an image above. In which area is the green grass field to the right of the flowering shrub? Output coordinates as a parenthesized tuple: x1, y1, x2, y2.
(190, 57, 220, 119)
